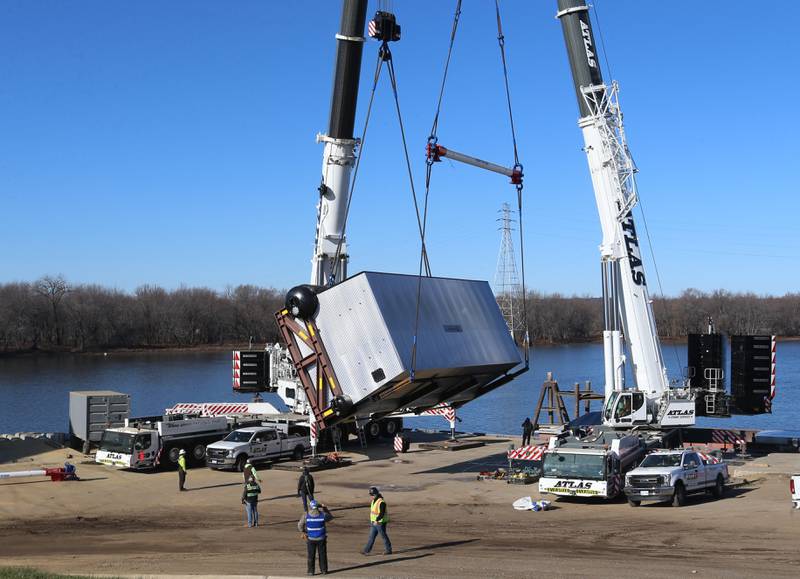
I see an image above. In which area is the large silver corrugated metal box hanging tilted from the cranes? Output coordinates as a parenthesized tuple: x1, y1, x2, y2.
(315, 272, 521, 414)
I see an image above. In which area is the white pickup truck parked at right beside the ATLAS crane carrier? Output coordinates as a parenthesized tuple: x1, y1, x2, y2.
(625, 450, 729, 507)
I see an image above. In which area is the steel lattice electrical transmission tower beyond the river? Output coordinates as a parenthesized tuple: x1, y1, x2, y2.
(494, 203, 525, 340)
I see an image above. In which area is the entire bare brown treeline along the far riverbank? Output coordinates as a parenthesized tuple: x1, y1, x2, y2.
(0, 276, 800, 352)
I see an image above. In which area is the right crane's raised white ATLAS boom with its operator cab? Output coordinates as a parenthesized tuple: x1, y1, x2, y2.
(556, 0, 694, 427)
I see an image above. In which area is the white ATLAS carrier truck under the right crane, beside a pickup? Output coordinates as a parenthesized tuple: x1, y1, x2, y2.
(539, 429, 646, 499)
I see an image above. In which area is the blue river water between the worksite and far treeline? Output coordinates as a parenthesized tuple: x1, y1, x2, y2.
(0, 342, 800, 434)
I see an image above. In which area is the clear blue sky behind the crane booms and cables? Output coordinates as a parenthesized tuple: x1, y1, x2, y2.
(0, 0, 800, 295)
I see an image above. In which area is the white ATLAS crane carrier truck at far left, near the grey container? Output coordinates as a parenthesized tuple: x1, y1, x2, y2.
(95, 414, 253, 470)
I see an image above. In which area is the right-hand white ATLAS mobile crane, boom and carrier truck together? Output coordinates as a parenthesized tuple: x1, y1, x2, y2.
(539, 0, 695, 498)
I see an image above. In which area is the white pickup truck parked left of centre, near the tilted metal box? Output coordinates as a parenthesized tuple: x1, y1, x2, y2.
(206, 426, 311, 472)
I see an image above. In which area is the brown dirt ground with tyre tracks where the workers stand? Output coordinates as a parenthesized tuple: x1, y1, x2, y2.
(0, 438, 800, 577)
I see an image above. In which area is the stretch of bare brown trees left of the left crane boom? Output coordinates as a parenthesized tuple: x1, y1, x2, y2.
(0, 276, 284, 352)
